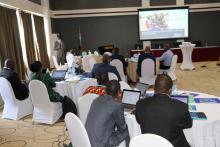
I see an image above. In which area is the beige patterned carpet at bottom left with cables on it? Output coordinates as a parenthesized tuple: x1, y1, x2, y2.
(0, 115, 69, 147)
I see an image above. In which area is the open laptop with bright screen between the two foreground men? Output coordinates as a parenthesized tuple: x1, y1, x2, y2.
(122, 89, 141, 111)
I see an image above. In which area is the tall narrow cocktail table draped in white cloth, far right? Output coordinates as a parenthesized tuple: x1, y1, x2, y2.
(179, 42, 195, 70)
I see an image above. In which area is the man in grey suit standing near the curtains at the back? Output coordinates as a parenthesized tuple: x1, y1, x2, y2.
(54, 34, 65, 65)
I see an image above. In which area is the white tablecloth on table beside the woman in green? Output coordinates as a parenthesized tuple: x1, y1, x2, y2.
(54, 78, 97, 105)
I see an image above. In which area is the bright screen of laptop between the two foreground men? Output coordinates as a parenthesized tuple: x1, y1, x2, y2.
(122, 89, 141, 105)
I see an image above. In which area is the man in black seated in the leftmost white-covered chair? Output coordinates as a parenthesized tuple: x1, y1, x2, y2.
(0, 59, 29, 100)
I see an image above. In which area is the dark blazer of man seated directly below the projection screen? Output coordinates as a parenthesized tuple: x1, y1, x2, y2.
(137, 52, 156, 77)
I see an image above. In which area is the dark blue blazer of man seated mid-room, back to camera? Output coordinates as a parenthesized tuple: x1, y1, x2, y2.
(90, 63, 121, 81)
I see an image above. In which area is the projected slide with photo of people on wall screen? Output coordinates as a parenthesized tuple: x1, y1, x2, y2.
(139, 8, 188, 40)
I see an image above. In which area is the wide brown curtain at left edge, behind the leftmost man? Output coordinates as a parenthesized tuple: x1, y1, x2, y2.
(0, 6, 25, 79)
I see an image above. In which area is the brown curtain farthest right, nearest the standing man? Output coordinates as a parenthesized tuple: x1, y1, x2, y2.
(34, 15, 50, 68)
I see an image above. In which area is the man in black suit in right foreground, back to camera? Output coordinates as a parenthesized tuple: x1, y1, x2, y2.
(135, 75, 192, 147)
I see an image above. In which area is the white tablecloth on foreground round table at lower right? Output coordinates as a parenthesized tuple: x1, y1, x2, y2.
(125, 91, 220, 147)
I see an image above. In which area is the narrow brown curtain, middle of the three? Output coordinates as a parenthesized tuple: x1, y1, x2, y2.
(21, 12, 37, 65)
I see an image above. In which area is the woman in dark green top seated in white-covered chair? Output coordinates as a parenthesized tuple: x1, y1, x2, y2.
(29, 61, 77, 117)
